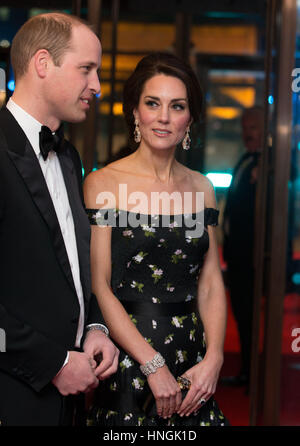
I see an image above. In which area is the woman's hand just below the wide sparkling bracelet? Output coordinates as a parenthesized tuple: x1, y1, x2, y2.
(148, 365, 181, 418)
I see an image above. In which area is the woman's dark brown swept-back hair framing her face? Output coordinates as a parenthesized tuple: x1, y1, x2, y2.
(123, 53, 203, 146)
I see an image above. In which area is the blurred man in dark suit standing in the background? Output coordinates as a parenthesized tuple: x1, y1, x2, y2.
(221, 106, 264, 386)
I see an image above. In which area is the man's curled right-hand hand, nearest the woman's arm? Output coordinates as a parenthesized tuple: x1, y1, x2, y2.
(83, 330, 119, 380)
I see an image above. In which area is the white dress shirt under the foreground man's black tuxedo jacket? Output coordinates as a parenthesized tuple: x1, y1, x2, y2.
(7, 99, 84, 347)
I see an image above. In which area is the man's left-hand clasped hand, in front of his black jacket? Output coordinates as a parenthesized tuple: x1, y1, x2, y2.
(52, 351, 99, 396)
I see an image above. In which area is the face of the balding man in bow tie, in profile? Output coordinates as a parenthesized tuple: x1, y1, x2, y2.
(44, 25, 101, 122)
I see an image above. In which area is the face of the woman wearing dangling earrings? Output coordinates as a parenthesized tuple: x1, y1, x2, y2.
(134, 74, 191, 150)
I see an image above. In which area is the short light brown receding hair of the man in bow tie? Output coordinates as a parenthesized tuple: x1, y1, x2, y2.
(10, 12, 89, 80)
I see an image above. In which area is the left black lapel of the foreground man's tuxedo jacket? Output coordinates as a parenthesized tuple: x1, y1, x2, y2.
(0, 111, 76, 291)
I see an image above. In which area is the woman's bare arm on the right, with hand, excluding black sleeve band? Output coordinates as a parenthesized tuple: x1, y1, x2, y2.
(180, 176, 226, 415)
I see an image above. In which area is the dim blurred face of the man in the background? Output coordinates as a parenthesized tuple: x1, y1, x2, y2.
(242, 113, 263, 152)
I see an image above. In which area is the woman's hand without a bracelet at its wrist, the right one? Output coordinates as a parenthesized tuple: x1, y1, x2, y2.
(178, 357, 223, 416)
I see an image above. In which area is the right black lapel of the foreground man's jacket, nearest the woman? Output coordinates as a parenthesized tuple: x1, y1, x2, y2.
(58, 146, 91, 299)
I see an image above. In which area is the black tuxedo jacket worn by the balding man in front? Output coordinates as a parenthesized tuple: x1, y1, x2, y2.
(0, 109, 102, 425)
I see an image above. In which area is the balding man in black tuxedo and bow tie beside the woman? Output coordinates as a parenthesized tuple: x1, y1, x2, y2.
(0, 13, 118, 426)
